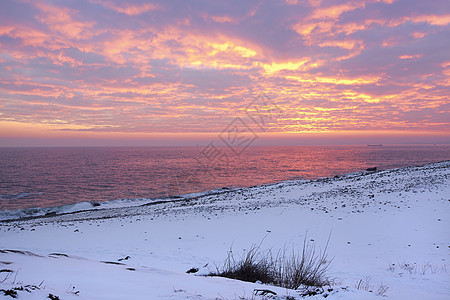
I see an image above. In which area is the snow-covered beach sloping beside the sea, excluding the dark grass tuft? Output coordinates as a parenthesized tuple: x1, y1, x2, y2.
(0, 161, 450, 299)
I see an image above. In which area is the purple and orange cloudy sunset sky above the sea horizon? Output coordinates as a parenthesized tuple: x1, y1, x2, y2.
(0, 0, 450, 146)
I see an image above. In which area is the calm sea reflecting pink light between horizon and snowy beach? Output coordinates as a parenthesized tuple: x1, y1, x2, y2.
(0, 146, 450, 211)
